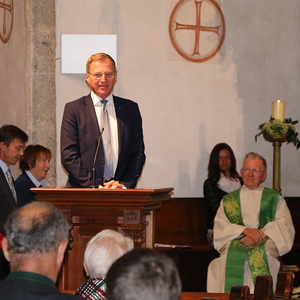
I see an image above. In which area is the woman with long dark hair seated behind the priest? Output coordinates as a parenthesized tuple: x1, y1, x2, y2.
(203, 143, 242, 244)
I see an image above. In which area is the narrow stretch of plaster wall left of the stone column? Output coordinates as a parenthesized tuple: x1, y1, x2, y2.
(0, 1, 30, 178)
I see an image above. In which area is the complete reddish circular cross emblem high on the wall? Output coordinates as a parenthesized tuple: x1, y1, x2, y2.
(169, 0, 225, 62)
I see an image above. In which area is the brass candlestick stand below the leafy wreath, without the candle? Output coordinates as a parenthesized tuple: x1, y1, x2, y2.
(263, 132, 287, 192)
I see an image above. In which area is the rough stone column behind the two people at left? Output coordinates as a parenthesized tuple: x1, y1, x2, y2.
(25, 0, 57, 186)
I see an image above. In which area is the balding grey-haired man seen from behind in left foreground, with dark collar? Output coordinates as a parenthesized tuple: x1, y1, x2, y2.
(0, 201, 76, 300)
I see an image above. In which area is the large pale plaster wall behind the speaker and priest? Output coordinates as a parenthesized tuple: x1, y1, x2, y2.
(56, 0, 300, 197)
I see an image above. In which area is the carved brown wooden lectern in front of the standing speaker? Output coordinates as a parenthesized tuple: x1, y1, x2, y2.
(31, 188, 173, 290)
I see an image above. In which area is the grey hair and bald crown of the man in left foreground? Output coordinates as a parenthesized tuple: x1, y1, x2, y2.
(5, 201, 71, 254)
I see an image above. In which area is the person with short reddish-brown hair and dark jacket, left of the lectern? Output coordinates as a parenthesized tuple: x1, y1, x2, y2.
(15, 145, 52, 205)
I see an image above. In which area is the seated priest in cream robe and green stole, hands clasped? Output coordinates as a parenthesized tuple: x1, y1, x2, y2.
(207, 152, 295, 293)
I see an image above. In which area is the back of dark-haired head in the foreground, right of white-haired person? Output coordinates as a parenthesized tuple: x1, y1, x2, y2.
(106, 248, 181, 300)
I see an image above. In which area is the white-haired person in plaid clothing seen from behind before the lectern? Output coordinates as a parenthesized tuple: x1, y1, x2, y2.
(75, 229, 133, 300)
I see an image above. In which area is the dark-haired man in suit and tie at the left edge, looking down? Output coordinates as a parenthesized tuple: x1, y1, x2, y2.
(0, 125, 28, 280)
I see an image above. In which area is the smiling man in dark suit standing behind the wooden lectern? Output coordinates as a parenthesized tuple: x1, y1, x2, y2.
(61, 53, 145, 188)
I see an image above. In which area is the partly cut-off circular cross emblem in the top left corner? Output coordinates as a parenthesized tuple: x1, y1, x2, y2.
(0, 0, 14, 44)
